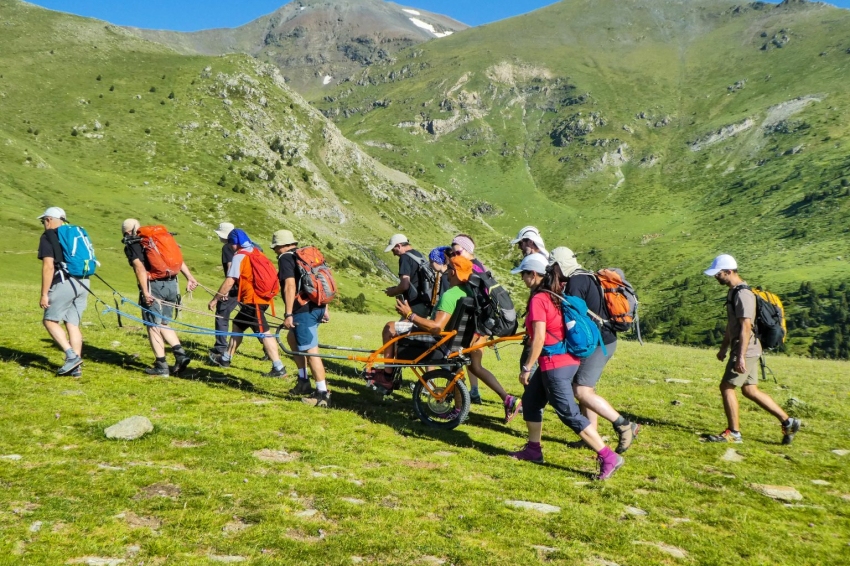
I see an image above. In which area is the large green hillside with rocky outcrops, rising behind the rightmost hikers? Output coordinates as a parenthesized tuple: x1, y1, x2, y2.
(317, 0, 850, 358)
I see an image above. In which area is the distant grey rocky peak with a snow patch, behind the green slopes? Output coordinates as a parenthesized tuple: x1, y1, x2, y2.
(122, 0, 467, 97)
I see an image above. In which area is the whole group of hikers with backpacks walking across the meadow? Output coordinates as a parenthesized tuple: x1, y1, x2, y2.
(38, 207, 800, 480)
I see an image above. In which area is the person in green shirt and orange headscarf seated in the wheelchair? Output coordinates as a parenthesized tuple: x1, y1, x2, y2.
(369, 255, 521, 423)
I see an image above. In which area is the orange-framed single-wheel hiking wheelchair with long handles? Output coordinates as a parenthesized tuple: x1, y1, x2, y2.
(277, 297, 524, 429)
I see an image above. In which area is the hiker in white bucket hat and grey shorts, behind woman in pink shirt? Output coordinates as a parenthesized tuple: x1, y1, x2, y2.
(549, 247, 641, 454)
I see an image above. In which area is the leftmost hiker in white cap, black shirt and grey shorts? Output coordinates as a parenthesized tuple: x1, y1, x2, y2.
(38, 206, 89, 377)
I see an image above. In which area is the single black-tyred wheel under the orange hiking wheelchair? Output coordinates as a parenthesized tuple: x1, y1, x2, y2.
(413, 369, 470, 430)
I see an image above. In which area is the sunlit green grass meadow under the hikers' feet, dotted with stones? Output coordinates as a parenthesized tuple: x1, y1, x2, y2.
(0, 284, 850, 565)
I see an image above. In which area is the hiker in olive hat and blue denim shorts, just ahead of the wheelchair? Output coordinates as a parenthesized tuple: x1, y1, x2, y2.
(272, 230, 331, 408)
